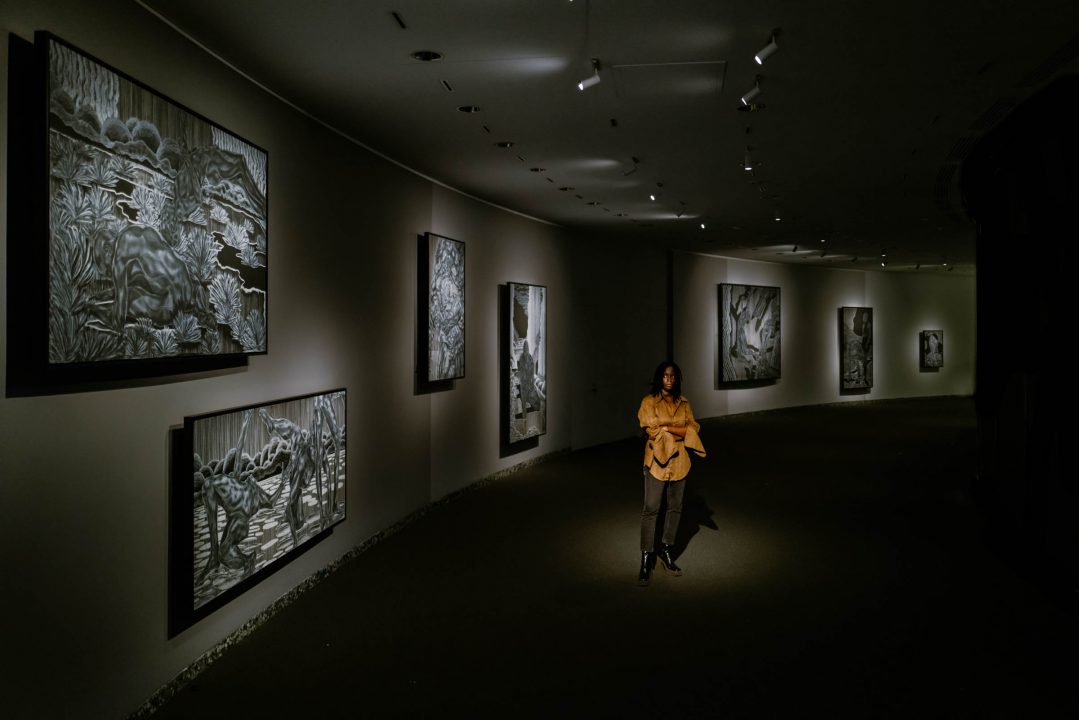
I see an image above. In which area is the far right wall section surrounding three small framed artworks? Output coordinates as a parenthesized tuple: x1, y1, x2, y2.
(673, 253, 975, 418)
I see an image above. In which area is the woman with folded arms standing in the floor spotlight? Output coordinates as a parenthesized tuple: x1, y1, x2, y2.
(637, 362, 705, 586)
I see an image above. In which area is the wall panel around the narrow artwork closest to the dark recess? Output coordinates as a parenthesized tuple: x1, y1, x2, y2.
(429, 186, 572, 500)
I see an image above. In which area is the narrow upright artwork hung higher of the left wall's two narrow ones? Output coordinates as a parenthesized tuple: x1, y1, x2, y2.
(427, 233, 465, 381)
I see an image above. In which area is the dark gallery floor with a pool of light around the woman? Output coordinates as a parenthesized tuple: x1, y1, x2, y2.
(145, 398, 1079, 719)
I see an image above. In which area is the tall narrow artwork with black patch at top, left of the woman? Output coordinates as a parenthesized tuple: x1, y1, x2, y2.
(508, 283, 547, 443)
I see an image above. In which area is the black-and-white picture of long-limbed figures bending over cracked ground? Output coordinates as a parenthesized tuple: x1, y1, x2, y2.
(187, 390, 347, 609)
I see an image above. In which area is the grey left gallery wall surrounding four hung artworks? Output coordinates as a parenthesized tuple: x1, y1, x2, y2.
(0, 0, 570, 718)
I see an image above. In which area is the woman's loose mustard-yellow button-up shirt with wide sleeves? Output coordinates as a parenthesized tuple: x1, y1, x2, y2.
(637, 395, 705, 480)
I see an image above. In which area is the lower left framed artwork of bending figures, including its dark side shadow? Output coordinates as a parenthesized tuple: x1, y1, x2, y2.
(168, 388, 347, 637)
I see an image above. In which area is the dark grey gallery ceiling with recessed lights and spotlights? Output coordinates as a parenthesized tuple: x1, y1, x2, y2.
(139, 0, 1079, 274)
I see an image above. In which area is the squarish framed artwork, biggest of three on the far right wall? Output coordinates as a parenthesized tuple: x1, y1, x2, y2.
(720, 283, 781, 382)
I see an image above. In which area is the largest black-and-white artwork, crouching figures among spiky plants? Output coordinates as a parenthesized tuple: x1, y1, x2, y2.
(49, 38, 267, 364)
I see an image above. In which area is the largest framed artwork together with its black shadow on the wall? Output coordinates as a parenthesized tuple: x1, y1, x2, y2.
(9, 31, 269, 394)
